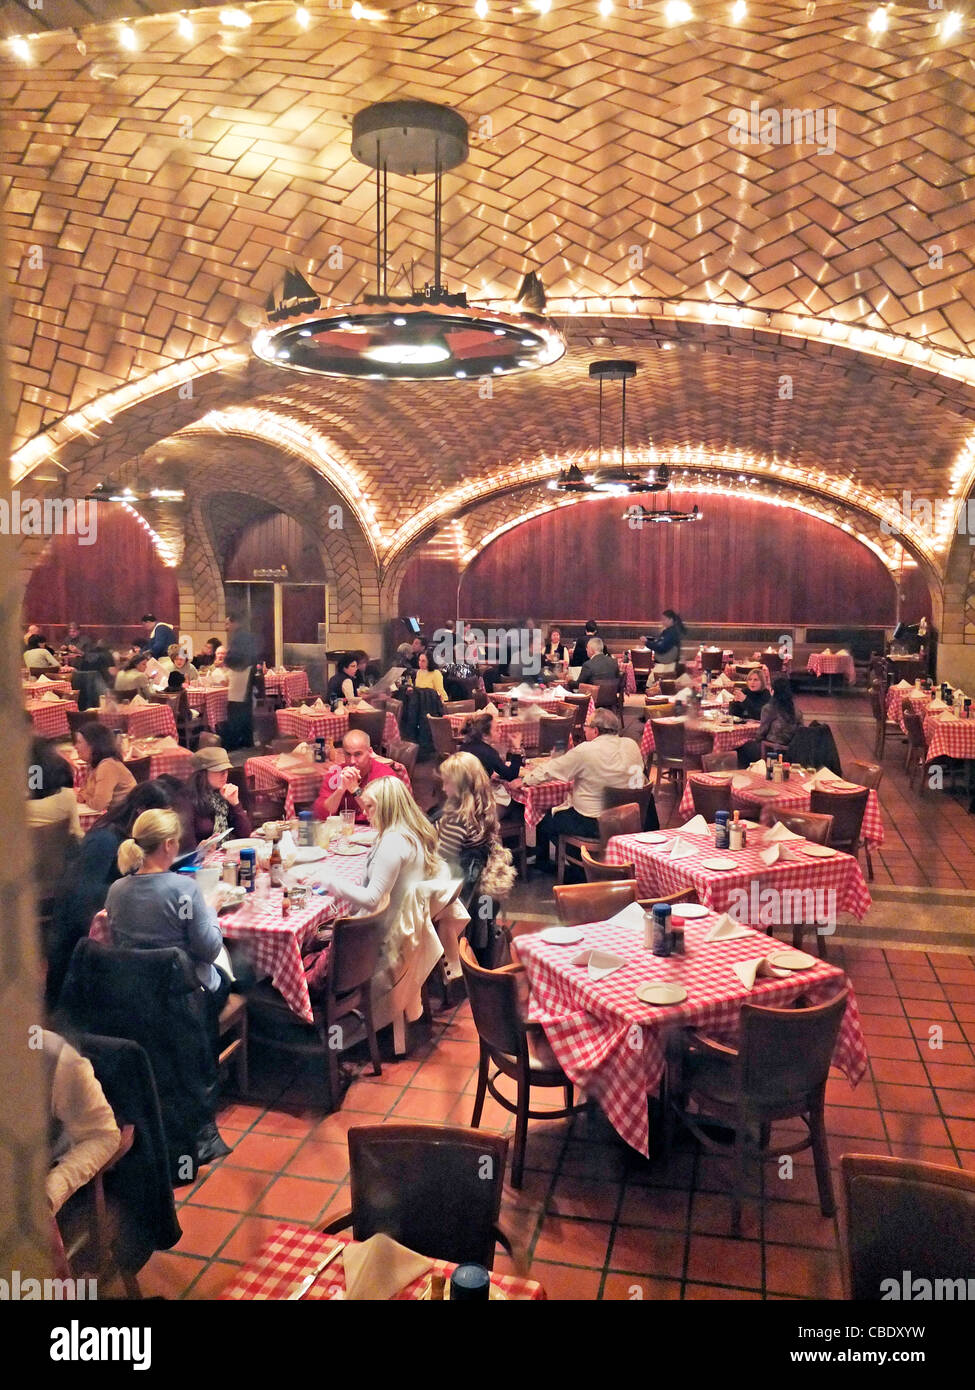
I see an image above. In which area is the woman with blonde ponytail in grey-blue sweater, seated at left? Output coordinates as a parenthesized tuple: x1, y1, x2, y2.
(104, 810, 229, 1012)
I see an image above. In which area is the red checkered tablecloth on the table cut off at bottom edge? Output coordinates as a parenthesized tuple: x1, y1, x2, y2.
(220, 1226, 545, 1302)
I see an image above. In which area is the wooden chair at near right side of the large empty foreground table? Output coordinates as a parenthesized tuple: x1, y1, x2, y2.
(673, 988, 848, 1236)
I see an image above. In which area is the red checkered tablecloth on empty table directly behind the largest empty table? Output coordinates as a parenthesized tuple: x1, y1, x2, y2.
(606, 830, 871, 922)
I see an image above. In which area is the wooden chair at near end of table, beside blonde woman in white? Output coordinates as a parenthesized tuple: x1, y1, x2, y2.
(248, 897, 389, 1109)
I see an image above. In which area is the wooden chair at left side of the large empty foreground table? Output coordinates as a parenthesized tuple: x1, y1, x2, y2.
(460, 940, 584, 1187)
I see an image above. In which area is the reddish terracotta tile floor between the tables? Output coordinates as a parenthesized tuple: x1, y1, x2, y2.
(140, 696, 975, 1300)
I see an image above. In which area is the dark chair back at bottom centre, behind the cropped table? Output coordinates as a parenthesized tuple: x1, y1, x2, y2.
(324, 1125, 512, 1269)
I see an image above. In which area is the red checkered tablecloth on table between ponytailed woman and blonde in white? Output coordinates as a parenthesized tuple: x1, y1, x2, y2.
(220, 848, 369, 1023)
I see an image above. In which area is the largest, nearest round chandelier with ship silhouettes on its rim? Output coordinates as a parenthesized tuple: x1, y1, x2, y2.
(253, 101, 566, 381)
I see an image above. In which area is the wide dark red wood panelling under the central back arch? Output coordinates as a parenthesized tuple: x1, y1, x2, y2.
(399, 493, 930, 626)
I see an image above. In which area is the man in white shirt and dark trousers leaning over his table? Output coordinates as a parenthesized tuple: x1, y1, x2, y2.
(522, 709, 656, 869)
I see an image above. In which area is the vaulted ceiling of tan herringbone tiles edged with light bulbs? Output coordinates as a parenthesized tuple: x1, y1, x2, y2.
(0, 0, 975, 578)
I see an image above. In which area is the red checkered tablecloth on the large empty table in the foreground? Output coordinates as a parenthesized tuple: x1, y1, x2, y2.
(517, 917, 867, 1154)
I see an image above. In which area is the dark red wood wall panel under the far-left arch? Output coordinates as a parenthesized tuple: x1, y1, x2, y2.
(24, 502, 179, 631)
